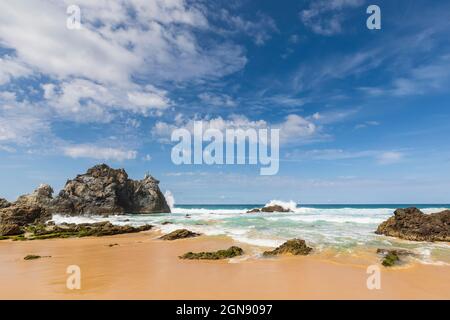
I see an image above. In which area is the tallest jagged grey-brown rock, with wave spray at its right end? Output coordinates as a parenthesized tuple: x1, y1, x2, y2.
(51, 164, 170, 215)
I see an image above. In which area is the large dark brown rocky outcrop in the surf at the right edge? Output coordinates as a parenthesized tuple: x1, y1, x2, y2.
(375, 208, 450, 242)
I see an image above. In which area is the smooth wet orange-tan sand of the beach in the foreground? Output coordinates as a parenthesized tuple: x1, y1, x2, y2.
(0, 231, 450, 299)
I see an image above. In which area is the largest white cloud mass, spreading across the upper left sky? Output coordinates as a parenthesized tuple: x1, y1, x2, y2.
(0, 0, 247, 122)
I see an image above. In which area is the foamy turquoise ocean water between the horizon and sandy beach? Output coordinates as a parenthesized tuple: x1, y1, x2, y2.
(53, 201, 450, 265)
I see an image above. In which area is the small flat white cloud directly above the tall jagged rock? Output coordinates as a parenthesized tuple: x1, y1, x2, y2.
(63, 144, 137, 161)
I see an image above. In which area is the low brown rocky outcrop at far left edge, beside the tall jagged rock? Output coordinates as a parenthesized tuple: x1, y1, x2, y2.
(0, 204, 51, 236)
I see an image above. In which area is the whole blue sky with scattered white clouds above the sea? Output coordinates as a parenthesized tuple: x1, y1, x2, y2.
(0, 0, 450, 204)
